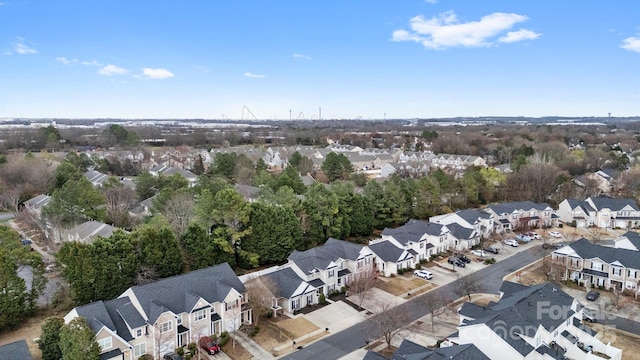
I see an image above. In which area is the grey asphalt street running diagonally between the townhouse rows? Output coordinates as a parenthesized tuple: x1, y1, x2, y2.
(283, 246, 544, 360)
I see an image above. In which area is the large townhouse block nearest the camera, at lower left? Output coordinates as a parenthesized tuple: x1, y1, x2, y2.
(63, 263, 252, 360)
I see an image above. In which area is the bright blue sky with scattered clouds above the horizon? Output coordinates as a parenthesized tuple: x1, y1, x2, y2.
(0, 0, 640, 119)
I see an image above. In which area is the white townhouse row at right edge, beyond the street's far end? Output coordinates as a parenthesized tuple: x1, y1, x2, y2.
(558, 197, 640, 229)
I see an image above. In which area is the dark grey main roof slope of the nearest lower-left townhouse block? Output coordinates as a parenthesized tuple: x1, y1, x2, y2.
(131, 263, 245, 323)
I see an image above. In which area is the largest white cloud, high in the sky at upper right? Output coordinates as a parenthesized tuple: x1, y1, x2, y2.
(391, 11, 539, 49)
